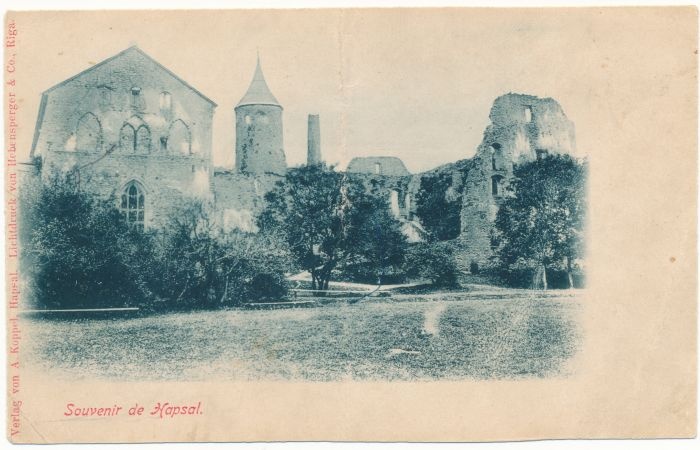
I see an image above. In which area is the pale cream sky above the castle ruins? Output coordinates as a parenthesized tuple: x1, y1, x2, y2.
(9, 9, 668, 172)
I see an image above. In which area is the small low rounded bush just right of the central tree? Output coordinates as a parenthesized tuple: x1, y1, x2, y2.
(406, 242, 458, 287)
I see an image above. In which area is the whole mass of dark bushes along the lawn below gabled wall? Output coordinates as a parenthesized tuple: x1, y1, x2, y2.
(20, 176, 289, 309)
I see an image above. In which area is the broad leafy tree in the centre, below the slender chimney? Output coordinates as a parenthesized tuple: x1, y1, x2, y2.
(258, 165, 406, 290)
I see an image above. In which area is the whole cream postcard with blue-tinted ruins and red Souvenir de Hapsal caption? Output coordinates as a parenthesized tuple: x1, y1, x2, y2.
(5, 9, 697, 442)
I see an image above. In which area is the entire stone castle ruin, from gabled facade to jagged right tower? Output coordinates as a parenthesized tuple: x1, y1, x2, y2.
(24, 47, 576, 270)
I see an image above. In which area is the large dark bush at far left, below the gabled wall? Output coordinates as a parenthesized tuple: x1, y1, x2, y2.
(20, 176, 157, 308)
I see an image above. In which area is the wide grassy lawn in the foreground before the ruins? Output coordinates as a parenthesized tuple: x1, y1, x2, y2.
(22, 290, 581, 381)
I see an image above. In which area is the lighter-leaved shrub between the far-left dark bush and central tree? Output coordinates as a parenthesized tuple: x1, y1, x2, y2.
(158, 201, 286, 308)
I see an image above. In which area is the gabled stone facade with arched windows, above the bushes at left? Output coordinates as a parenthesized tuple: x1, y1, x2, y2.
(32, 47, 216, 227)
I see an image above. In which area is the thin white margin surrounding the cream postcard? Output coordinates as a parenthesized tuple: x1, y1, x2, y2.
(0, 0, 700, 450)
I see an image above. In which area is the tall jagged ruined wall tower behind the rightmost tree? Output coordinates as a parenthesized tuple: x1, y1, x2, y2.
(460, 93, 576, 268)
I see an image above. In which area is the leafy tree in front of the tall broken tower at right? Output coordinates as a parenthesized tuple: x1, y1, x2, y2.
(494, 155, 586, 289)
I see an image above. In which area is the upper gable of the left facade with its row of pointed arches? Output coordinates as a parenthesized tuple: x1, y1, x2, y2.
(32, 47, 216, 164)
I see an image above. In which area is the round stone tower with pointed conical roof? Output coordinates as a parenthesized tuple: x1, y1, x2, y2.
(234, 58, 287, 175)
